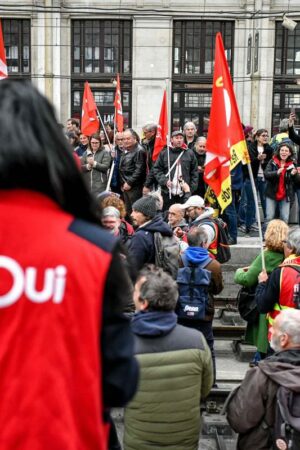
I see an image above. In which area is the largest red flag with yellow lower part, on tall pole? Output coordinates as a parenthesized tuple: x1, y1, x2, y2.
(204, 33, 249, 211)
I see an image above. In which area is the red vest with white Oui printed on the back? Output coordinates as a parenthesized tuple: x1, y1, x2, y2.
(0, 190, 111, 450)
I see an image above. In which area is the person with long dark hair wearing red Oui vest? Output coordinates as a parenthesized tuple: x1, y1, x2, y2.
(0, 80, 138, 450)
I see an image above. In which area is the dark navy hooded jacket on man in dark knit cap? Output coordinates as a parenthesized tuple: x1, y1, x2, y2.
(128, 216, 173, 270)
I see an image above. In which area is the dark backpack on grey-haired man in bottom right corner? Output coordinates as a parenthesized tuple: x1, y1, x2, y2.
(273, 386, 300, 450)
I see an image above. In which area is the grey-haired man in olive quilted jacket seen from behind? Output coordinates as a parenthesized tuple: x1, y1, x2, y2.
(124, 266, 213, 450)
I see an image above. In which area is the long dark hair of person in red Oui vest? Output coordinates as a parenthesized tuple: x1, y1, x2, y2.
(0, 79, 98, 222)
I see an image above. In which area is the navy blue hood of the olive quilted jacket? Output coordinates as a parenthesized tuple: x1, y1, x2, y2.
(131, 311, 177, 336)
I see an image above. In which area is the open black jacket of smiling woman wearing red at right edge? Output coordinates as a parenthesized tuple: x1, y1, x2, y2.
(264, 159, 300, 202)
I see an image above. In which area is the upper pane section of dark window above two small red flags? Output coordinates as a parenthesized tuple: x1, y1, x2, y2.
(72, 20, 132, 75)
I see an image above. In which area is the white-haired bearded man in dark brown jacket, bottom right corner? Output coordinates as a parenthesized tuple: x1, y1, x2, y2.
(226, 309, 300, 450)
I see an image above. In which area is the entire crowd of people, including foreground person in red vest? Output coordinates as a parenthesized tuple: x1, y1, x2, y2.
(0, 80, 300, 450)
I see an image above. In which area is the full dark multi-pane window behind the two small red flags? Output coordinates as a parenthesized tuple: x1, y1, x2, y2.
(71, 20, 132, 127)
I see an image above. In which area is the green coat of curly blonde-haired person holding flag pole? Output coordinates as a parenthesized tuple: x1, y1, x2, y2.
(234, 250, 284, 353)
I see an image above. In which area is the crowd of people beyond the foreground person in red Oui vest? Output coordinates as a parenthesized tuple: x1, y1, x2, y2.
(64, 113, 300, 450)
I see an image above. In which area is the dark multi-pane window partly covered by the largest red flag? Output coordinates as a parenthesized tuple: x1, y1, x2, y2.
(172, 20, 234, 134)
